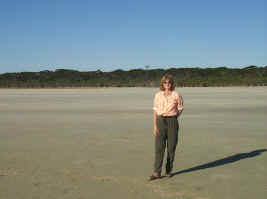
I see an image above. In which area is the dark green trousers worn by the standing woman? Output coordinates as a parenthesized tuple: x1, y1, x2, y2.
(154, 116, 179, 174)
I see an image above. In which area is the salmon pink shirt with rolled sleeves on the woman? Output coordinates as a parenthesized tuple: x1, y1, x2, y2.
(153, 91, 184, 116)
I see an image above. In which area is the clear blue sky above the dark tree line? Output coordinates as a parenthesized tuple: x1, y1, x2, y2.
(0, 0, 267, 73)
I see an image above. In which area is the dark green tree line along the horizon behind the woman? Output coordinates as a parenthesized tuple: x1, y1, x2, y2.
(0, 66, 267, 88)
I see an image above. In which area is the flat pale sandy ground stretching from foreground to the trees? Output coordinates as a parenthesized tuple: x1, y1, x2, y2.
(0, 87, 267, 199)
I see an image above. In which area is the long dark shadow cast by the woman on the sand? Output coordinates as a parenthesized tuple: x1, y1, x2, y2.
(172, 149, 267, 176)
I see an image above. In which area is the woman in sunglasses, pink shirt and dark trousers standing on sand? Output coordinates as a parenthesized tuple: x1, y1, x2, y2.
(149, 74, 184, 180)
